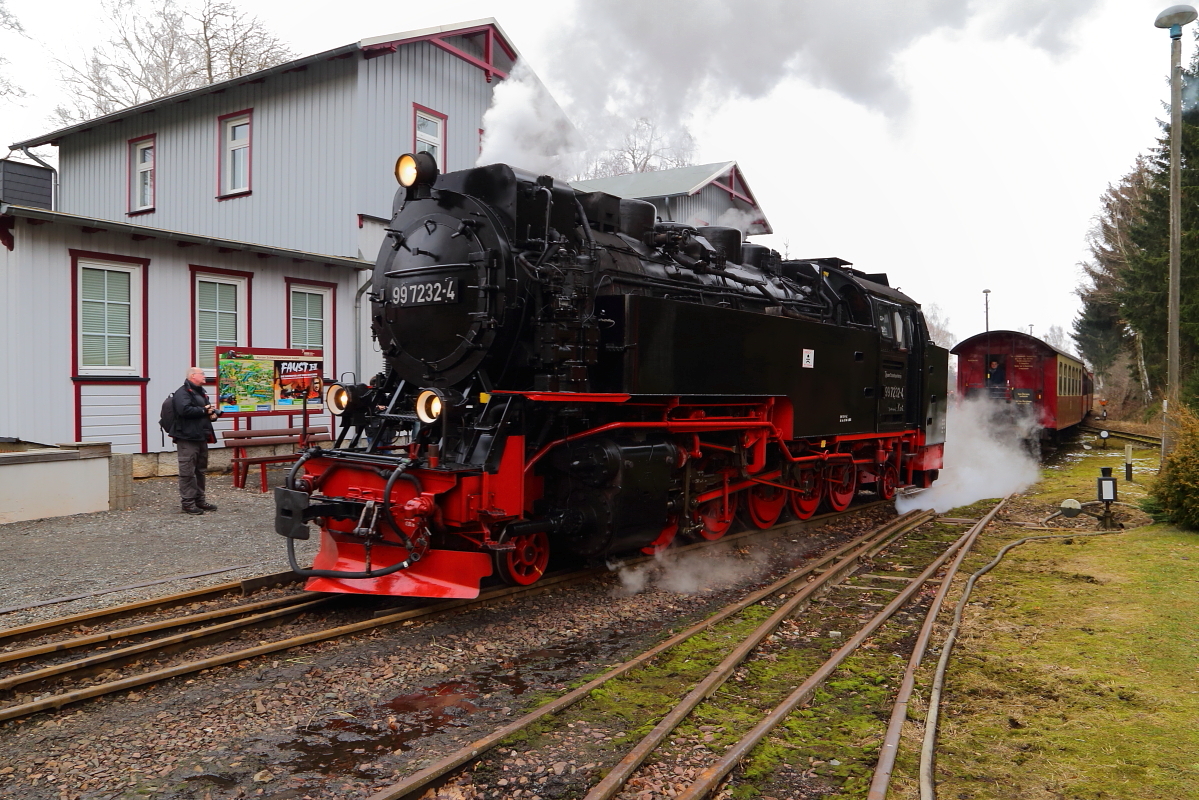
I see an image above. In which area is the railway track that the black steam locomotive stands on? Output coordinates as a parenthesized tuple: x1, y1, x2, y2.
(0, 503, 880, 722)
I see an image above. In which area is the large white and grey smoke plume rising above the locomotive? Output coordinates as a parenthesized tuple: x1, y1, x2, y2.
(478, 0, 1097, 176)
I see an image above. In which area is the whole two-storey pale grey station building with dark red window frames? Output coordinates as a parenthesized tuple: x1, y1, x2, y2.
(0, 18, 549, 475)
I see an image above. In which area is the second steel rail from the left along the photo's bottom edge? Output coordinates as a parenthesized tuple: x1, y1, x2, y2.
(584, 511, 933, 800)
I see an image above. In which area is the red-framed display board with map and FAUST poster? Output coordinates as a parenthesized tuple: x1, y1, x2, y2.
(217, 348, 325, 414)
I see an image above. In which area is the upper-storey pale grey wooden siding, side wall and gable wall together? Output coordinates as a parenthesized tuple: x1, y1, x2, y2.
(59, 42, 500, 257)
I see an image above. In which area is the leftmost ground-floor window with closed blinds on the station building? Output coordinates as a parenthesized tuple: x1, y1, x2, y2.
(78, 260, 141, 375)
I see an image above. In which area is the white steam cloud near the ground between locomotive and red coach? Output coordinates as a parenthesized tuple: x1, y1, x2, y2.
(896, 399, 1041, 513)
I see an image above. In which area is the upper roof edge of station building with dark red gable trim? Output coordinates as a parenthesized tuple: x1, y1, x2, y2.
(10, 17, 519, 150)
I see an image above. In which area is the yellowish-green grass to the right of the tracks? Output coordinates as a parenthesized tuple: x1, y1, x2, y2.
(888, 451, 1199, 800)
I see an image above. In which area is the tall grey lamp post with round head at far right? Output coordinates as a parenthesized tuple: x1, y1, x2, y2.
(1153, 6, 1199, 462)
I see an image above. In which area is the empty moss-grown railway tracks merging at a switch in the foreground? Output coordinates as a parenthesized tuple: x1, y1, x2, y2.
(357, 504, 1001, 800)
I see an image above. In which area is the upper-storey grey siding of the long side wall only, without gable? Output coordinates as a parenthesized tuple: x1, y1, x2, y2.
(60, 59, 357, 257)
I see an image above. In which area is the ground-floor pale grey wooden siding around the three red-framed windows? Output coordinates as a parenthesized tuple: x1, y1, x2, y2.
(0, 219, 359, 452)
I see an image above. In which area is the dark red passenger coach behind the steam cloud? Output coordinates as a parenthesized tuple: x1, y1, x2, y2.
(951, 331, 1093, 432)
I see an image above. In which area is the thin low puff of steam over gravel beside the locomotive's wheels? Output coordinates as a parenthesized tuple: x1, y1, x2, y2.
(610, 548, 766, 595)
